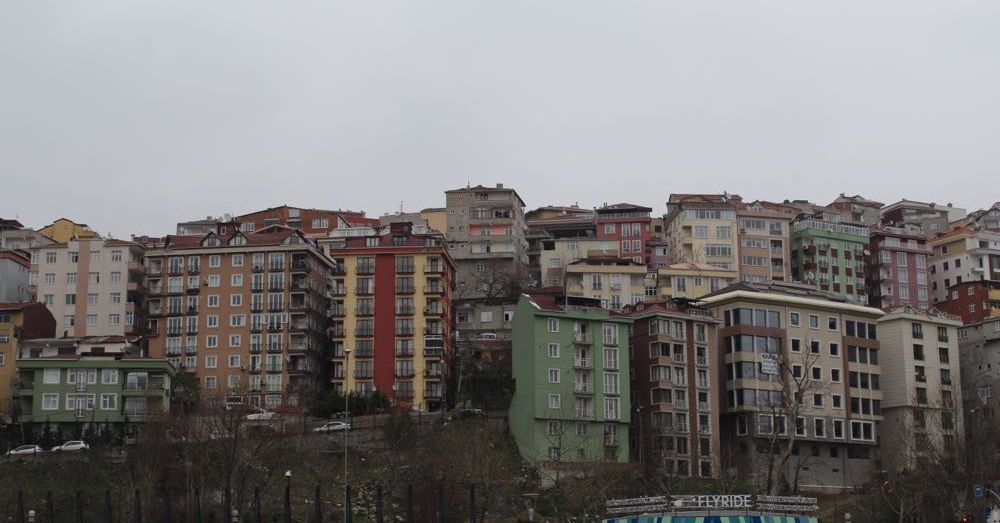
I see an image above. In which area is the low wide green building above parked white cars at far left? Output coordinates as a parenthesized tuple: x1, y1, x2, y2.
(14, 355, 175, 431)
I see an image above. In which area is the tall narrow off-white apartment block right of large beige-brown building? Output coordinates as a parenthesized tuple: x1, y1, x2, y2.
(878, 306, 963, 473)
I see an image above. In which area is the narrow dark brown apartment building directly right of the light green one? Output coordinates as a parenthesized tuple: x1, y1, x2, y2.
(624, 300, 722, 478)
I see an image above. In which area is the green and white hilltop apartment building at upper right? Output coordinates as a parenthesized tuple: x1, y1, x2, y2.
(791, 218, 868, 305)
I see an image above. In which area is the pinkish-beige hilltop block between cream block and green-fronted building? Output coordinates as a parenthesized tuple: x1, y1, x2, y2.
(736, 201, 798, 283)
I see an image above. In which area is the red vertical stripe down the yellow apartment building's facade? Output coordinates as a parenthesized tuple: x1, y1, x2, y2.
(375, 254, 396, 399)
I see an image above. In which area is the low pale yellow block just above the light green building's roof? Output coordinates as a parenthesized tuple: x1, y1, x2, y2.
(565, 255, 655, 310)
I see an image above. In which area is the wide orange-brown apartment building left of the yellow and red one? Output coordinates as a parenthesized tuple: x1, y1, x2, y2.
(146, 226, 333, 409)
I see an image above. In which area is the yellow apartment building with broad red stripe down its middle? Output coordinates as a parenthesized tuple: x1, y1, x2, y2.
(319, 222, 455, 410)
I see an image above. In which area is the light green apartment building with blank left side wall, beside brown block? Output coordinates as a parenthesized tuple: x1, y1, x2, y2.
(510, 294, 632, 462)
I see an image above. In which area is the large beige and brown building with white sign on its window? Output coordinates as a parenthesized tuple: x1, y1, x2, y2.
(702, 283, 883, 491)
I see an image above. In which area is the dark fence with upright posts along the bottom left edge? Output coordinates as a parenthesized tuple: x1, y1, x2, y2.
(2, 481, 485, 523)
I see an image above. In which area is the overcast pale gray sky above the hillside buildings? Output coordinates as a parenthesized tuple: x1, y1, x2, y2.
(0, 0, 1000, 237)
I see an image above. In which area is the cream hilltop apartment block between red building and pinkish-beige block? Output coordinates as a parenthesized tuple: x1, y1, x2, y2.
(663, 194, 742, 270)
